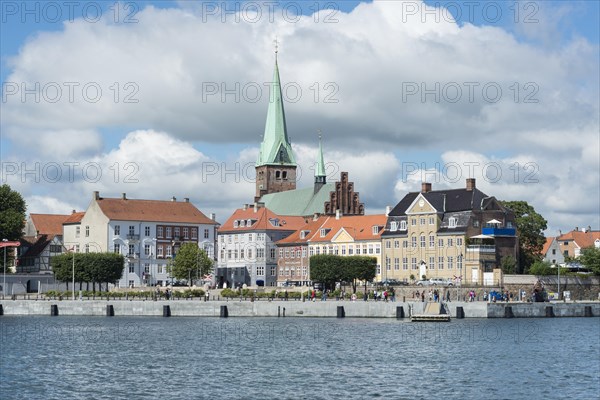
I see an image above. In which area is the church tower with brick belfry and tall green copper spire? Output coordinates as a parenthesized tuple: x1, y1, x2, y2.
(254, 50, 296, 202)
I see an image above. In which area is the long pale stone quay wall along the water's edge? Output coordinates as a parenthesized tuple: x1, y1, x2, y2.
(0, 299, 600, 318)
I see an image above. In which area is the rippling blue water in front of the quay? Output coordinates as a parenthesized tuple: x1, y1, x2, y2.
(0, 316, 600, 399)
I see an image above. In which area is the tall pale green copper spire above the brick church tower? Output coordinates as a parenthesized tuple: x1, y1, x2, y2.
(256, 57, 296, 166)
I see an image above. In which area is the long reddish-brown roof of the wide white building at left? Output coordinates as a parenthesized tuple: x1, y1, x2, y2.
(96, 198, 216, 225)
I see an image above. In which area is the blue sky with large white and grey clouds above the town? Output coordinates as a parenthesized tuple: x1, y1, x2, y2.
(0, 0, 600, 236)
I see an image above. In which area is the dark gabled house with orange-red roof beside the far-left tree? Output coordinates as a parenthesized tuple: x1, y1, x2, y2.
(17, 214, 70, 274)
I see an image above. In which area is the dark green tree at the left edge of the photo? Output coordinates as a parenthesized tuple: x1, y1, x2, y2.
(0, 184, 26, 270)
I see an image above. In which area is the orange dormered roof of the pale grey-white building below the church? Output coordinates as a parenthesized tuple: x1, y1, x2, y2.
(219, 206, 306, 233)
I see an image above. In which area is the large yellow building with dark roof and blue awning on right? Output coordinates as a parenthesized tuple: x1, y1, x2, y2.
(382, 178, 518, 285)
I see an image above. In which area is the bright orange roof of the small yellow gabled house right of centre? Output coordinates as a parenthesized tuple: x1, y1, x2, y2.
(310, 214, 387, 243)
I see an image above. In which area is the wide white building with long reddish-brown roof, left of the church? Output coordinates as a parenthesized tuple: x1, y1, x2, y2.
(64, 192, 217, 287)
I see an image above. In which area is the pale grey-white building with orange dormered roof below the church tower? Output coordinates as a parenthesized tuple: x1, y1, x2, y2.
(216, 203, 305, 287)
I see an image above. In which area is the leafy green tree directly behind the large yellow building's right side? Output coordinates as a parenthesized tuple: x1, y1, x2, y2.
(500, 201, 548, 274)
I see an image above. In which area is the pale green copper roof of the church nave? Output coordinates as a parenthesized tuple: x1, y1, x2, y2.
(260, 183, 335, 216)
